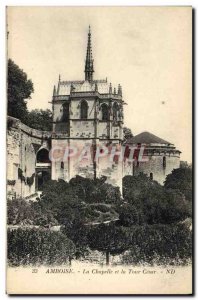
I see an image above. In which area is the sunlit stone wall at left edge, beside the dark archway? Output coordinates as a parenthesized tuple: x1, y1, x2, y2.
(7, 117, 50, 199)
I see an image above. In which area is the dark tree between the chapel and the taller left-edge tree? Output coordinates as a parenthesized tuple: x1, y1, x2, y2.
(26, 109, 52, 131)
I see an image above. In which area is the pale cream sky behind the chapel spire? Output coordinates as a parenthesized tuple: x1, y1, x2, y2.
(7, 6, 192, 162)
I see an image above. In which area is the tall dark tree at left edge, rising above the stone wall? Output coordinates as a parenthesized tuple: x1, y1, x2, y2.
(7, 59, 34, 122)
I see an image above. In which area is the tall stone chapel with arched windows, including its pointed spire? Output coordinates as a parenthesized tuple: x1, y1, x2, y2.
(51, 27, 124, 188)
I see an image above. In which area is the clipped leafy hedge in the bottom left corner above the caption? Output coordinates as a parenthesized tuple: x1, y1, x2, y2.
(7, 229, 75, 266)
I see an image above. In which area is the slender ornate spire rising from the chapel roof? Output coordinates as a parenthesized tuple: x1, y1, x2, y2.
(85, 25, 94, 81)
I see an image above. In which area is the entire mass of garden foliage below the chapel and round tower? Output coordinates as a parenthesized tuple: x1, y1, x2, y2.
(8, 170, 192, 264)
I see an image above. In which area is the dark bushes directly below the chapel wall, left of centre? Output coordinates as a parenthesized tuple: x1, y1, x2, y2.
(40, 176, 120, 225)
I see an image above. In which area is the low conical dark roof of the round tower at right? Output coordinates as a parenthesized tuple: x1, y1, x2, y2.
(127, 131, 172, 145)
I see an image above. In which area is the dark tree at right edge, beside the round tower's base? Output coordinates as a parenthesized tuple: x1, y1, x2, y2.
(164, 167, 192, 201)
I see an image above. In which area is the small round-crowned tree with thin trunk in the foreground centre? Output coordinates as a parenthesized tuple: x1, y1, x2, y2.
(88, 223, 130, 265)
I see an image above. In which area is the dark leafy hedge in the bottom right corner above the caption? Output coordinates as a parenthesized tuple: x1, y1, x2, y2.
(122, 224, 192, 265)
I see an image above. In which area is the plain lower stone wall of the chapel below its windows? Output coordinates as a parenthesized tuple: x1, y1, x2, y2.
(52, 139, 123, 191)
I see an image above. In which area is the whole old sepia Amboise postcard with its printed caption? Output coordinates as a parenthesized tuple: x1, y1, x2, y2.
(7, 6, 193, 295)
